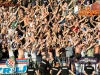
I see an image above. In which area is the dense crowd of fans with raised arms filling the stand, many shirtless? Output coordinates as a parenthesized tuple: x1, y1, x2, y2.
(0, 0, 100, 75)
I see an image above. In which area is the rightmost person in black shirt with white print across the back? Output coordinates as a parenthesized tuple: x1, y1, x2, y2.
(84, 62, 95, 75)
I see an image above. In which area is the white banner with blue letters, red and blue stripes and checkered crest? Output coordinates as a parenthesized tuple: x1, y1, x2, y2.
(0, 59, 27, 74)
